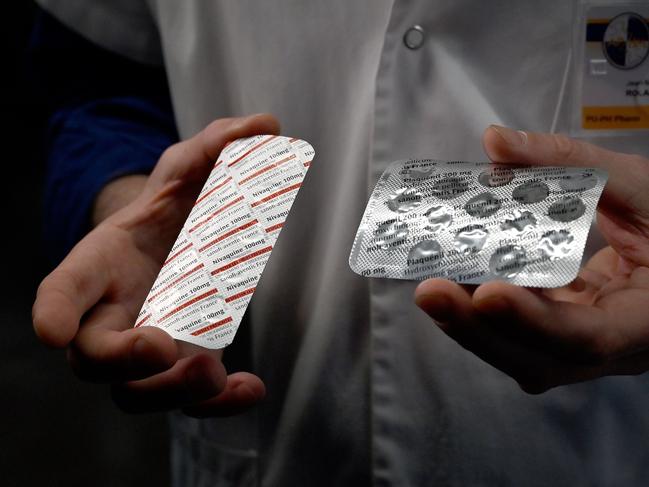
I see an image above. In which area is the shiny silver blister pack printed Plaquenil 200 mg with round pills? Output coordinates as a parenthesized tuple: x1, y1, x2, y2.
(349, 159, 607, 287)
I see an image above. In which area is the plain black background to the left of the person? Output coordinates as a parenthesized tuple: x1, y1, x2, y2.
(0, 0, 169, 487)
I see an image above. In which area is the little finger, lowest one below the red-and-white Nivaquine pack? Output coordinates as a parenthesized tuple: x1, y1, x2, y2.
(182, 372, 266, 418)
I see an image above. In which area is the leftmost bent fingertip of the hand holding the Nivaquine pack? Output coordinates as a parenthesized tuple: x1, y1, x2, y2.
(32, 234, 111, 348)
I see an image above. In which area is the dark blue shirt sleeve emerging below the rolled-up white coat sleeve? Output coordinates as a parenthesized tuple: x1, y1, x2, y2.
(29, 12, 178, 260)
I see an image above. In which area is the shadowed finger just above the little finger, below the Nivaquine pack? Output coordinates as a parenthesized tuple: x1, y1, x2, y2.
(111, 352, 227, 413)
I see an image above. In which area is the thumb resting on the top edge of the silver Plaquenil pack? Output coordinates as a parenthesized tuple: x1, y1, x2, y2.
(482, 125, 649, 211)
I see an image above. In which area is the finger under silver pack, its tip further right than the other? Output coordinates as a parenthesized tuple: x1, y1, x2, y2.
(473, 282, 623, 364)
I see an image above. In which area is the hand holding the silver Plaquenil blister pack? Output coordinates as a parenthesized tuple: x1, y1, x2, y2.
(415, 127, 649, 393)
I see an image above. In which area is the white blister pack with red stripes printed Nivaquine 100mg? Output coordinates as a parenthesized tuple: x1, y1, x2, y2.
(135, 135, 315, 349)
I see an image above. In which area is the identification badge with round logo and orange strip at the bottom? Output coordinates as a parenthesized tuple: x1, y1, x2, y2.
(574, 0, 649, 135)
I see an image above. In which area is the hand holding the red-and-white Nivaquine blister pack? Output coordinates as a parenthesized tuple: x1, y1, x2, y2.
(33, 115, 279, 416)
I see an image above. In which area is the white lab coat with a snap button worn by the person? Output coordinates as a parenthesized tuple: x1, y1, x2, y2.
(40, 0, 649, 487)
